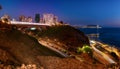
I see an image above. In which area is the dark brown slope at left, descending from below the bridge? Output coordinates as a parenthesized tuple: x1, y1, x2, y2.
(0, 24, 62, 65)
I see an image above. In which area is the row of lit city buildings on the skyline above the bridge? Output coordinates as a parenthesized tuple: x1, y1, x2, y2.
(1, 13, 63, 25)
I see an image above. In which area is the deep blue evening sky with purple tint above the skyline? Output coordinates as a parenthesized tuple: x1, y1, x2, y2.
(0, 0, 120, 27)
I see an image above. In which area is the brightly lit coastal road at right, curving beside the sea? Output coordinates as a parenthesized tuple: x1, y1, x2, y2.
(91, 40, 116, 64)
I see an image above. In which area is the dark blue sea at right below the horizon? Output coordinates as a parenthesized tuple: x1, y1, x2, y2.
(79, 28, 120, 48)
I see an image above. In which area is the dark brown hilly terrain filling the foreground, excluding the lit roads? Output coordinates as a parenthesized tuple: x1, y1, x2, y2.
(0, 23, 117, 69)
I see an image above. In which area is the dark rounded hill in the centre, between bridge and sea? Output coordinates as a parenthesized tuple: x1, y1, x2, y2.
(38, 26, 89, 51)
